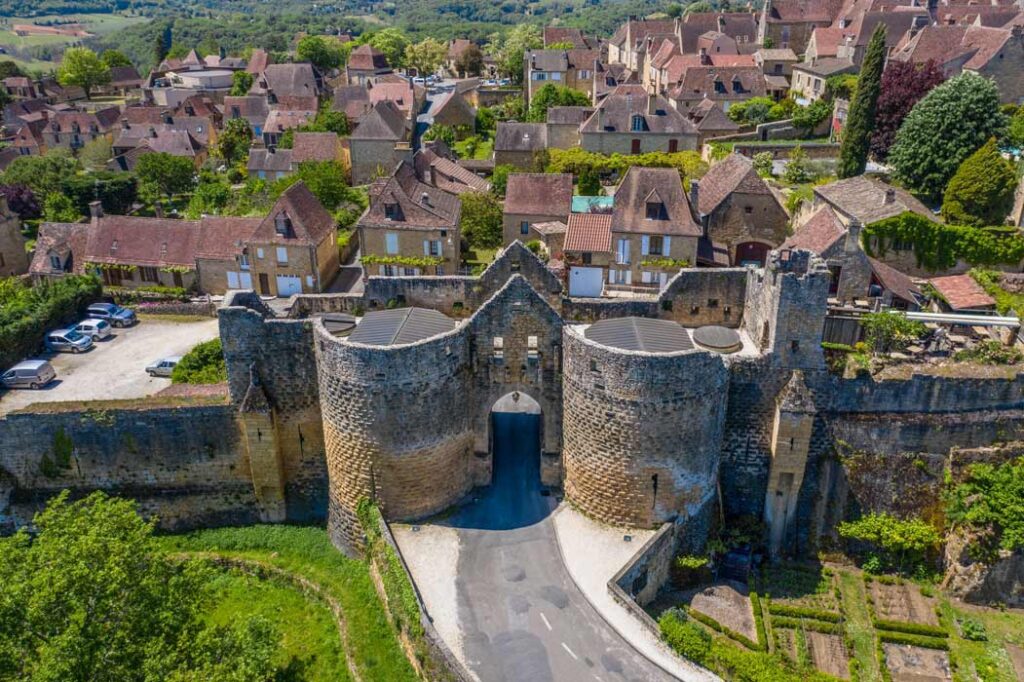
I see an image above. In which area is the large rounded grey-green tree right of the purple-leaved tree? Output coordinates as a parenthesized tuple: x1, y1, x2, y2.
(889, 73, 1007, 198)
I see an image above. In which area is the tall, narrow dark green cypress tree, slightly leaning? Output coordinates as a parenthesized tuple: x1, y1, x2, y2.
(836, 22, 886, 178)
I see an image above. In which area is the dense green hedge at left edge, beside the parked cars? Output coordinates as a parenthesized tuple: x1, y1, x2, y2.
(0, 275, 102, 369)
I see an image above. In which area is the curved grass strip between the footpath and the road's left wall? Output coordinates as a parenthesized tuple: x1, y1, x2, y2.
(163, 525, 417, 682)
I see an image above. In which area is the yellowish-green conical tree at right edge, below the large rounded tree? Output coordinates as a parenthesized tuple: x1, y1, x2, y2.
(942, 138, 1017, 227)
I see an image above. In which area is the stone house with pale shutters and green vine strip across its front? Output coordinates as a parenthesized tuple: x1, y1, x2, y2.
(355, 162, 462, 276)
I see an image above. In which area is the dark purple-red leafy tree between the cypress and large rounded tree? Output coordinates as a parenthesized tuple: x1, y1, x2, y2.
(871, 59, 946, 161)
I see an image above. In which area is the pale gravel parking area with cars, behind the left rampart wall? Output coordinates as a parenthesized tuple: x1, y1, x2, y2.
(0, 317, 218, 415)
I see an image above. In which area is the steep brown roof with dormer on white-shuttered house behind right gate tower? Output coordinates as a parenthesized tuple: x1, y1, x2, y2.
(606, 166, 703, 237)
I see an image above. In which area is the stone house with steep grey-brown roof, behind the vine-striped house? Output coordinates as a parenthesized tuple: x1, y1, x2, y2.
(348, 100, 413, 185)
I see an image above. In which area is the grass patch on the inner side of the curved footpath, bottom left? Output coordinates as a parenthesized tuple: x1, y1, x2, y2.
(208, 570, 351, 682)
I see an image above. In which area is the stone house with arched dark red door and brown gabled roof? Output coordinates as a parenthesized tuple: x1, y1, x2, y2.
(690, 154, 790, 266)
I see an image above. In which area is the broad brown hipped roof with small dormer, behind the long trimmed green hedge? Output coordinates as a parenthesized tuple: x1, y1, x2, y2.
(580, 85, 696, 135)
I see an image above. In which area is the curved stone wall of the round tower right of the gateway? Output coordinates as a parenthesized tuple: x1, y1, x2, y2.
(563, 328, 728, 527)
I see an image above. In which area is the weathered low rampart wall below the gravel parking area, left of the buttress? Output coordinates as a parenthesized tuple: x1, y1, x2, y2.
(0, 404, 259, 531)
